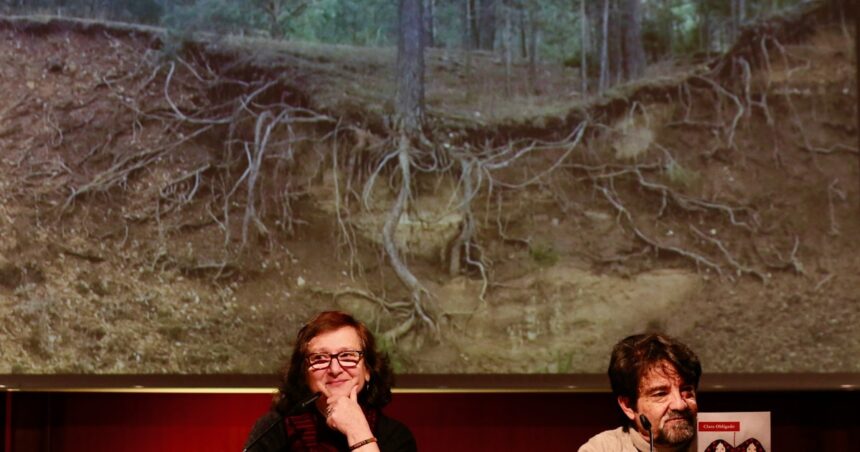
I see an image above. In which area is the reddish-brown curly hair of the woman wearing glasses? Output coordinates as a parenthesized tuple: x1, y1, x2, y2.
(272, 311, 394, 415)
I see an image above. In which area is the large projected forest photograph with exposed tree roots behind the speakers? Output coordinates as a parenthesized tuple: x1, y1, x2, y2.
(0, 0, 860, 376)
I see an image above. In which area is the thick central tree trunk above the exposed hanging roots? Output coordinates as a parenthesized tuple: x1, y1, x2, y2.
(395, 0, 424, 134)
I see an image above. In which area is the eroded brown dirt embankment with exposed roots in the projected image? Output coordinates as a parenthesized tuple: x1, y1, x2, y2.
(0, 11, 860, 373)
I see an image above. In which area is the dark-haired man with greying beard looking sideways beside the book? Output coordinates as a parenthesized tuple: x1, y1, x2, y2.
(579, 334, 702, 452)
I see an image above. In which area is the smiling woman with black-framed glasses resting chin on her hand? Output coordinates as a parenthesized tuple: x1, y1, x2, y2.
(245, 311, 417, 452)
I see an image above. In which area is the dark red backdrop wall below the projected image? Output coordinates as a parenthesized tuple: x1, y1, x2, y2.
(0, 391, 860, 452)
